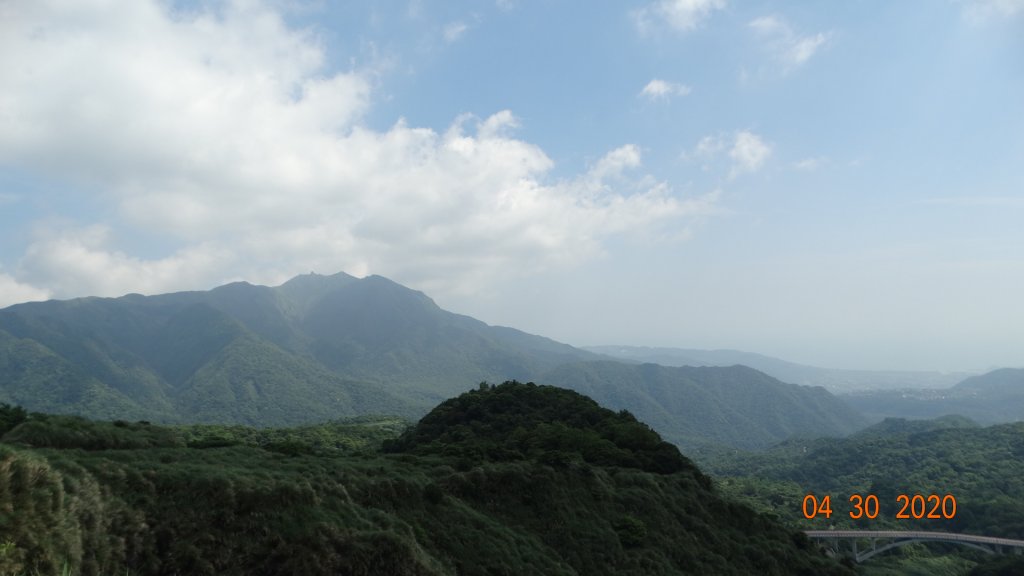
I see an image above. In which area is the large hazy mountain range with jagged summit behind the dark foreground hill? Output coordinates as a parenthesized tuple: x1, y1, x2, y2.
(0, 273, 862, 447)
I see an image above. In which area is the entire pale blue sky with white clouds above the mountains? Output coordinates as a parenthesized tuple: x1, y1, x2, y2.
(0, 0, 1024, 370)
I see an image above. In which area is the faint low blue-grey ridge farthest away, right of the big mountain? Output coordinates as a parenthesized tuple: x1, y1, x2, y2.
(584, 345, 972, 394)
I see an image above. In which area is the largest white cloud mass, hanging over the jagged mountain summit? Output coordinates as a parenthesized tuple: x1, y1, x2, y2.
(0, 0, 714, 297)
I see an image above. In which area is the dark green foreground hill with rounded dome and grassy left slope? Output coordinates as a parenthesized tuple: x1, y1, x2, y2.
(0, 382, 853, 576)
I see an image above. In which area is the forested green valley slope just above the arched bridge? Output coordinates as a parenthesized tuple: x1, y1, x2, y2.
(701, 417, 1024, 574)
